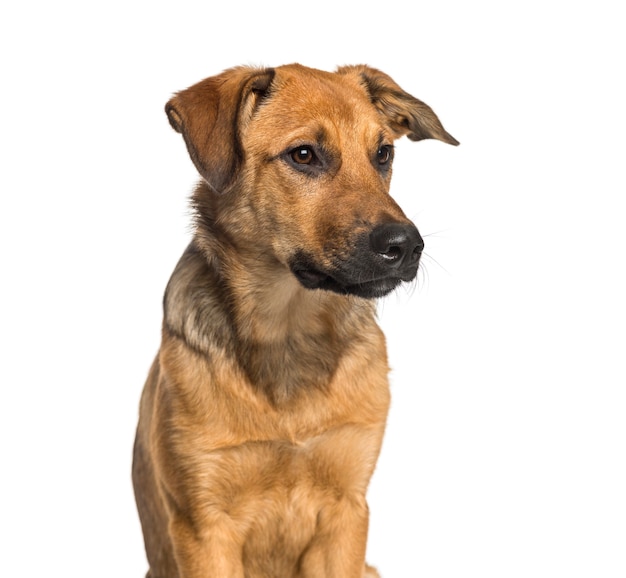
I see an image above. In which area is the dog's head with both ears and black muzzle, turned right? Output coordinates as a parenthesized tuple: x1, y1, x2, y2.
(166, 64, 458, 297)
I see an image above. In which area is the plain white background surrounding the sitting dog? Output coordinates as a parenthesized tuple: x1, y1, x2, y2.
(0, 0, 626, 578)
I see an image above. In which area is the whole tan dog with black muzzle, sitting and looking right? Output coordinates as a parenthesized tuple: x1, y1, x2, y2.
(133, 64, 458, 578)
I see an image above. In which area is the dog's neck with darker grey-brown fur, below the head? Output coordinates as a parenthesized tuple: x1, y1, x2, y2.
(164, 238, 375, 403)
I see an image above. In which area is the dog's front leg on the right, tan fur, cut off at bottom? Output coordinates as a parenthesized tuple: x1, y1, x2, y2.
(300, 496, 370, 578)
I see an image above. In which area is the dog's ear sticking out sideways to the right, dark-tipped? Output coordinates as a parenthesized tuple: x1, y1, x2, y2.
(337, 65, 459, 145)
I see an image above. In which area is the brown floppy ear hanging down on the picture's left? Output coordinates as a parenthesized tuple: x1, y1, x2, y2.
(165, 67, 274, 193)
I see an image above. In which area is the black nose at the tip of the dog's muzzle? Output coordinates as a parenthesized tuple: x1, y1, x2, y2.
(370, 223, 424, 269)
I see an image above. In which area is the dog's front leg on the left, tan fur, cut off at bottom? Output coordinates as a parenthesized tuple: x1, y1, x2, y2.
(170, 518, 244, 578)
